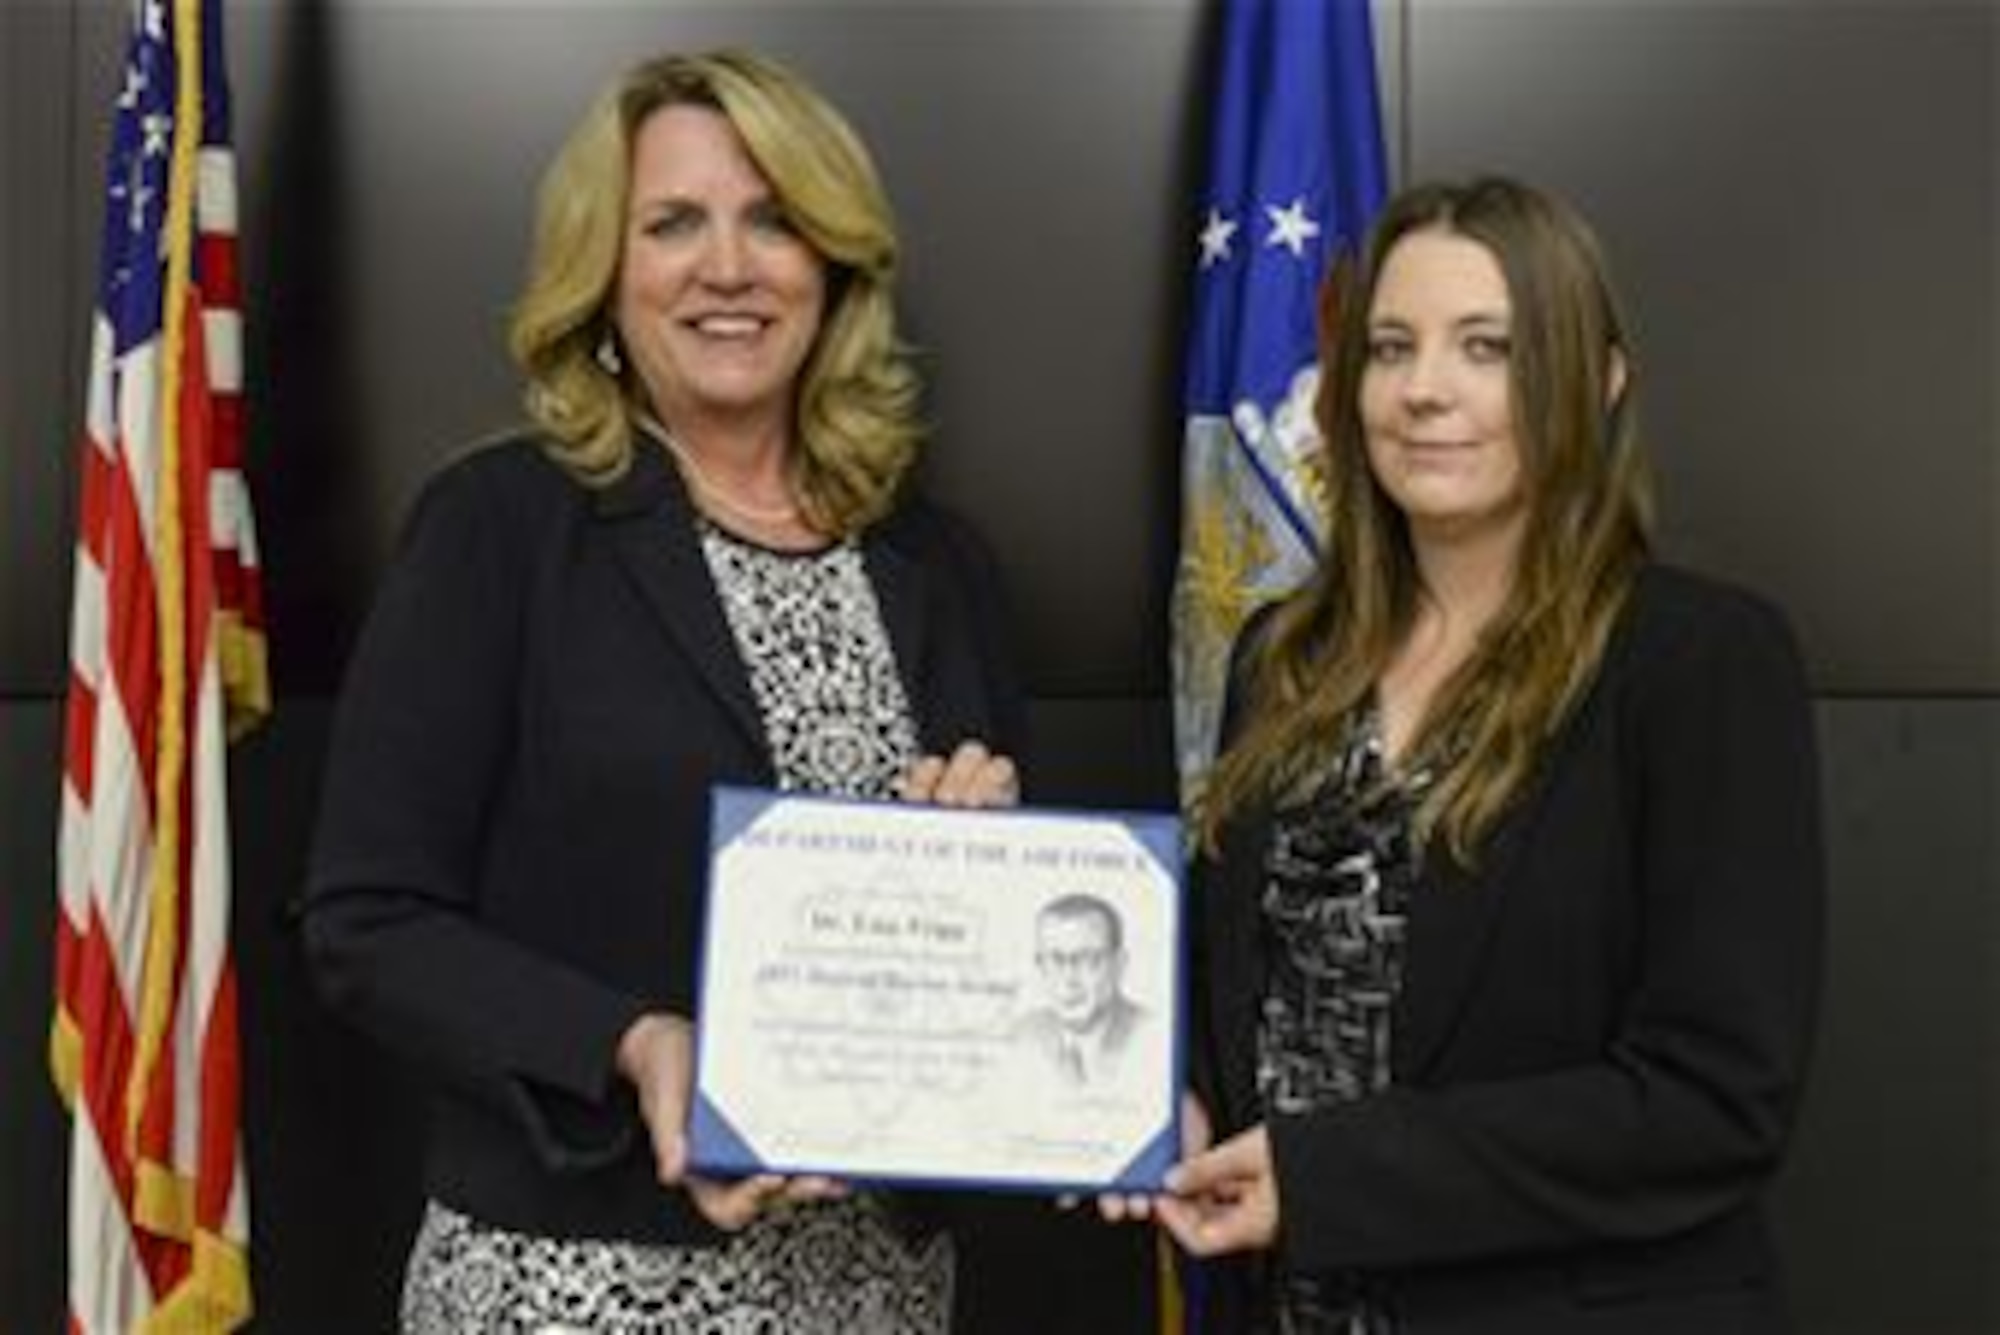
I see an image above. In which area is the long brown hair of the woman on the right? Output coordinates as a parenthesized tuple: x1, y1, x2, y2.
(1196, 176, 1652, 865)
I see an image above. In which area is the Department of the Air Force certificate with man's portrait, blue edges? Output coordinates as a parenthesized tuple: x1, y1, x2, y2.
(690, 787, 1182, 1191)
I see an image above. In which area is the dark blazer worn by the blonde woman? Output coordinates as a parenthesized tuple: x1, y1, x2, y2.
(302, 438, 1022, 1241)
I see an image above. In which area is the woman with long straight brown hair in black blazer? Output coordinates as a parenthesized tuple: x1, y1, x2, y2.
(1160, 178, 1824, 1335)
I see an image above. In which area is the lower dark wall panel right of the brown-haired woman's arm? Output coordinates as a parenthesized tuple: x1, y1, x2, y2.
(1778, 701, 2000, 1335)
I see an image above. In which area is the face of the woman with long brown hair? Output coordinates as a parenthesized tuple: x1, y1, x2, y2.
(1360, 228, 1526, 540)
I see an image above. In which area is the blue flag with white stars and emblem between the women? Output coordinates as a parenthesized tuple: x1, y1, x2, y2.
(1174, 0, 1388, 801)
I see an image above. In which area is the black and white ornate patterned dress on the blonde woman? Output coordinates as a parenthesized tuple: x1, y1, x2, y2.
(402, 520, 952, 1335)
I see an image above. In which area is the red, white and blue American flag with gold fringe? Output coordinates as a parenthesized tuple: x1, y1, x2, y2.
(50, 0, 270, 1335)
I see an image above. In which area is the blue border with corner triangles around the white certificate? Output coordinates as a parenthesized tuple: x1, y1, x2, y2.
(688, 783, 1190, 1195)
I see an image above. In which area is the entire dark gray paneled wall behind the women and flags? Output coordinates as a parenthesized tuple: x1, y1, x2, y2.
(0, 0, 2000, 1335)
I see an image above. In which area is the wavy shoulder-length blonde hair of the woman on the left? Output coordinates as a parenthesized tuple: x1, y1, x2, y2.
(508, 50, 922, 536)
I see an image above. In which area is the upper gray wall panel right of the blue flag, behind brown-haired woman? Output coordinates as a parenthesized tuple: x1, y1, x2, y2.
(1410, 0, 2000, 693)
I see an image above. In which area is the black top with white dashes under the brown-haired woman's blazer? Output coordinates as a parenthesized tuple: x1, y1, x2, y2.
(1256, 705, 1430, 1335)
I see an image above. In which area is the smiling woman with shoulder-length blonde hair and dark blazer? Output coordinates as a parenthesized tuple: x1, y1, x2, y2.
(304, 50, 1022, 1335)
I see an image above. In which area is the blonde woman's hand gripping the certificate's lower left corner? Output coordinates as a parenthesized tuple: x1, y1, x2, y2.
(618, 1011, 846, 1233)
